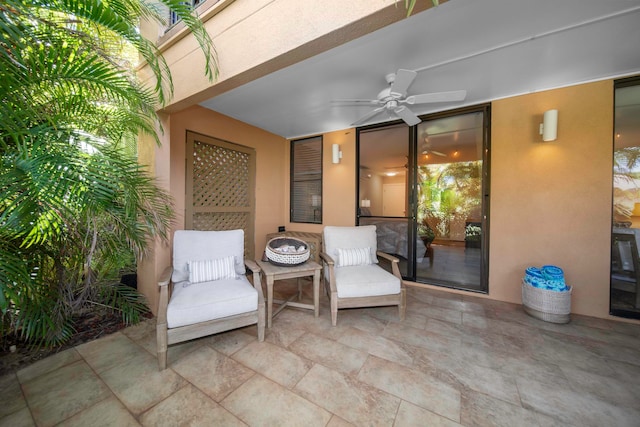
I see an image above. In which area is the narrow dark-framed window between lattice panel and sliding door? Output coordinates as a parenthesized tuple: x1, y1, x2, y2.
(290, 136, 322, 224)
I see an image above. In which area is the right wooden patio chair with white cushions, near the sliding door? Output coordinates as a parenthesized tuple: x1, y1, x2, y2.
(320, 225, 406, 326)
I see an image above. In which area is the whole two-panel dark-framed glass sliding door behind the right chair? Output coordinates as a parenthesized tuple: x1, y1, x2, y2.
(357, 106, 489, 292)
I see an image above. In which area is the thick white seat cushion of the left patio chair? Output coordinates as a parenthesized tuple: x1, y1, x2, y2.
(167, 276, 258, 328)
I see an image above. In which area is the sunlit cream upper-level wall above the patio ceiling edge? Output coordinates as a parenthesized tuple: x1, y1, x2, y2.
(140, 0, 431, 112)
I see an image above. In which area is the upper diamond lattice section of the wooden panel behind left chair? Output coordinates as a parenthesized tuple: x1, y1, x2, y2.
(193, 141, 250, 207)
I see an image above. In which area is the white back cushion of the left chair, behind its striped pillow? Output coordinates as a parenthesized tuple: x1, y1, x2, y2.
(171, 230, 245, 283)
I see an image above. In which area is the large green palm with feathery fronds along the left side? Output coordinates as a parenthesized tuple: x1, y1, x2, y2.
(0, 0, 217, 344)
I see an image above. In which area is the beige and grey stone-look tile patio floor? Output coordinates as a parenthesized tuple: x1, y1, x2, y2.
(0, 288, 640, 427)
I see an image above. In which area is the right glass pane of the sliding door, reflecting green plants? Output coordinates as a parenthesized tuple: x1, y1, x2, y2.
(416, 110, 488, 291)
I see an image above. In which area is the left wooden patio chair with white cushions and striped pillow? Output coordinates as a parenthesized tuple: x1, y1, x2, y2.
(156, 230, 265, 370)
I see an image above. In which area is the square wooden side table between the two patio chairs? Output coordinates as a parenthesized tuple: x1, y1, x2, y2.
(256, 260, 322, 328)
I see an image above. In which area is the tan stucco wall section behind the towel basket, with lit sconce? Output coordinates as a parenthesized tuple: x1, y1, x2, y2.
(489, 80, 613, 317)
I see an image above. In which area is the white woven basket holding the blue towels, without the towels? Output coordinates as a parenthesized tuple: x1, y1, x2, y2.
(522, 279, 573, 323)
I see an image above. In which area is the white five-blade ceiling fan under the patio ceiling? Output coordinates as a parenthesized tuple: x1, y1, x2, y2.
(334, 69, 467, 126)
